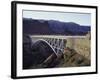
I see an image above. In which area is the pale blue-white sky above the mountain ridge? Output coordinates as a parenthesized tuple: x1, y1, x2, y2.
(23, 10, 91, 26)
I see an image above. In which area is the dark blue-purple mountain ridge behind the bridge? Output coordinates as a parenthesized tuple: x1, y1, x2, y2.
(23, 18, 90, 35)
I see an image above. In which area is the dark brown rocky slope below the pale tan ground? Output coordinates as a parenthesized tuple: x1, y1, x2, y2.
(56, 48, 90, 67)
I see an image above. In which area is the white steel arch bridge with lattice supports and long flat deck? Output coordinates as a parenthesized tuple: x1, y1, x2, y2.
(31, 35, 86, 56)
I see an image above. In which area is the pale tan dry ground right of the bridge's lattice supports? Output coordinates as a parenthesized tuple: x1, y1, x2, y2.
(66, 37, 91, 60)
